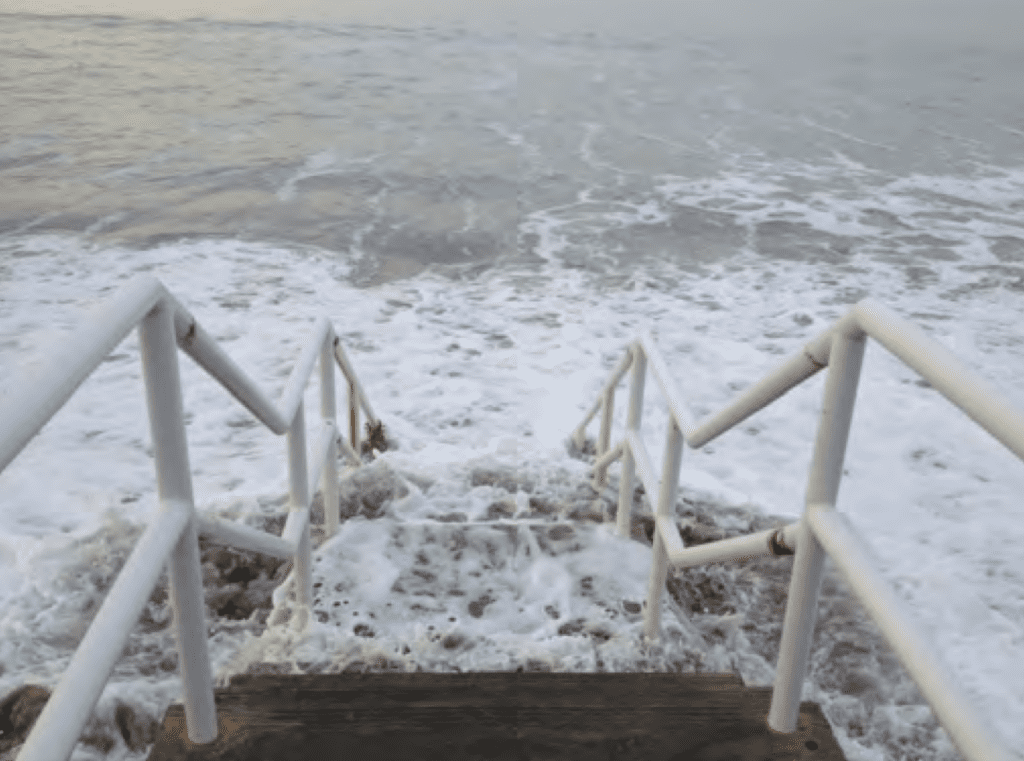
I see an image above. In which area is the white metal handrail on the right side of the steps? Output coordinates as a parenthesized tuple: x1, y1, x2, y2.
(572, 299, 1024, 761)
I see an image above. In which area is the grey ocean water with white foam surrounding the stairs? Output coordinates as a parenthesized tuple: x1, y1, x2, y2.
(0, 0, 1024, 761)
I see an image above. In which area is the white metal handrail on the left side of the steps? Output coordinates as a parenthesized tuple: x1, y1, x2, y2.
(0, 276, 379, 761)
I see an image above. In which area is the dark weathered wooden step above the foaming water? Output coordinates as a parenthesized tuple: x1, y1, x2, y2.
(150, 672, 845, 761)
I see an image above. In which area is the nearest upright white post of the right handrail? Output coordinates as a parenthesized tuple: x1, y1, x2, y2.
(768, 331, 866, 733)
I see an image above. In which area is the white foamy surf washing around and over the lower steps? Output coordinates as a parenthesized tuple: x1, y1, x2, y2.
(0, 227, 1024, 759)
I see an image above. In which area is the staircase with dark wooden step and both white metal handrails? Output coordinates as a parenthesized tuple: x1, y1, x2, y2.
(0, 277, 1024, 761)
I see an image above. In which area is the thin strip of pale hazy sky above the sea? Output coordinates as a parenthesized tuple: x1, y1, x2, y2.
(0, 0, 1024, 44)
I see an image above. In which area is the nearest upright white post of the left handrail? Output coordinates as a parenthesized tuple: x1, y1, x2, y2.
(138, 300, 217, 743)
